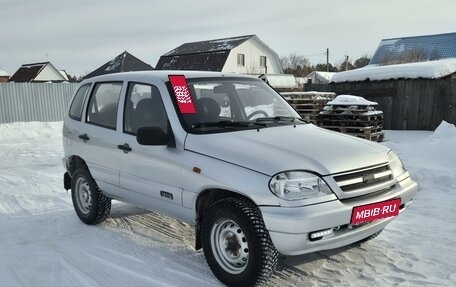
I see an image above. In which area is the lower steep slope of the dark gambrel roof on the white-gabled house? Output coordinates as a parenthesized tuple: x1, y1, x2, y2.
(155, 51, 230, 72)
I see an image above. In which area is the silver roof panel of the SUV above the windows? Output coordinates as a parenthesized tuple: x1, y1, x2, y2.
(81, 70, 256, 84)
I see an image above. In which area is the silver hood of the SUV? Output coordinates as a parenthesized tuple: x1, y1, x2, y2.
(185, 124, 389, 176)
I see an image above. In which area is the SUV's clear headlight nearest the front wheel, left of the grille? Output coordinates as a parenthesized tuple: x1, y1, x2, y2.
(269, 171, 332, 200)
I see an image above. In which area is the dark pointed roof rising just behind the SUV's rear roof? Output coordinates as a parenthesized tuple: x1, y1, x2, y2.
(84, 51, 154, 79)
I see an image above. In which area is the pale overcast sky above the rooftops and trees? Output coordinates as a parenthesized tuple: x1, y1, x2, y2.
(0, 0, 456, 75)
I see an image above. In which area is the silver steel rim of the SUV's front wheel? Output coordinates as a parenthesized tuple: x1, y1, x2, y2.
(211, 219, 249, 274)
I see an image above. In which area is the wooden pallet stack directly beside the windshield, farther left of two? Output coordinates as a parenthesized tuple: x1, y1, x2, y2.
(280, 92, 336, 124)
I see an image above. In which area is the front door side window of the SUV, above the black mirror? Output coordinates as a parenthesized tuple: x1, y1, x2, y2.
(124, 83, 168, 135)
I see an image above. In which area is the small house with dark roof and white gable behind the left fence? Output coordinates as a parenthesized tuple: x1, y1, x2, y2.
(9, 62, 68, 83)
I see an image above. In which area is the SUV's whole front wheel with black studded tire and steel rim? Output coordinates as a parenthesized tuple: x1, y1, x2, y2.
(201, 198, 279, 286)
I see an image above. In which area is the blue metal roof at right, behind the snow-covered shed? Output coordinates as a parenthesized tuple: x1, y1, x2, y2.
(369, 33, 456, 65)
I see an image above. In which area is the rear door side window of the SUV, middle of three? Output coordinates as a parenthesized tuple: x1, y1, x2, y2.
(87, 83, 122, 130)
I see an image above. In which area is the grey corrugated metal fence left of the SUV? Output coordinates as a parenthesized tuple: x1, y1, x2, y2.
(0, 83, 79, 123)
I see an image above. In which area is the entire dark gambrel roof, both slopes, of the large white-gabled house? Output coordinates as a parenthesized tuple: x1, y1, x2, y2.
(155, 35, 255, 72)
